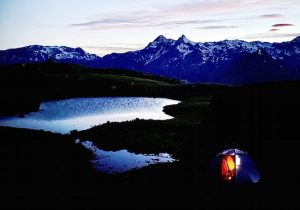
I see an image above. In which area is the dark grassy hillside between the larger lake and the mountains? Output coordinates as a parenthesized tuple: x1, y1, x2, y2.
(0, 61, 218, 115)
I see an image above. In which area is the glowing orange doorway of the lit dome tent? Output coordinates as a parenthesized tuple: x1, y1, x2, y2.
(221, 155, 236, 182)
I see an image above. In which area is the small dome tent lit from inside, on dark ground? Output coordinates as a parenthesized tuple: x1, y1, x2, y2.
(211, 149, 260, 184)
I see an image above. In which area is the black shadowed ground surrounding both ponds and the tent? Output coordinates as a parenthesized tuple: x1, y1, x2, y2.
(0, 64, 300, 209)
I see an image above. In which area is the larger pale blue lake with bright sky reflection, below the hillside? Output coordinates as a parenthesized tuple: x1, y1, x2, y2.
(0, 97, 178, 133)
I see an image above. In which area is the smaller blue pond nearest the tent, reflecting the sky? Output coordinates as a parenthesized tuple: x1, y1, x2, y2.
(76, 140, 176, 174)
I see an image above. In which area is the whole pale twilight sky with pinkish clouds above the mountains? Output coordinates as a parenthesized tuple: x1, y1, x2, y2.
(0, 0, 300, 56)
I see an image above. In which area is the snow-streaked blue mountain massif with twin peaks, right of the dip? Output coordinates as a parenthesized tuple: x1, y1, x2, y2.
(101, 35, 300, 84)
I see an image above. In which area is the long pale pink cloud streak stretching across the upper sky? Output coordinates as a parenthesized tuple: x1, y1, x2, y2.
(70, 0, 290, 30)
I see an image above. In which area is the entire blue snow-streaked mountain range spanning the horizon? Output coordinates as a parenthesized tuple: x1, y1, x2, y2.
(0, 35, 300, 85)
